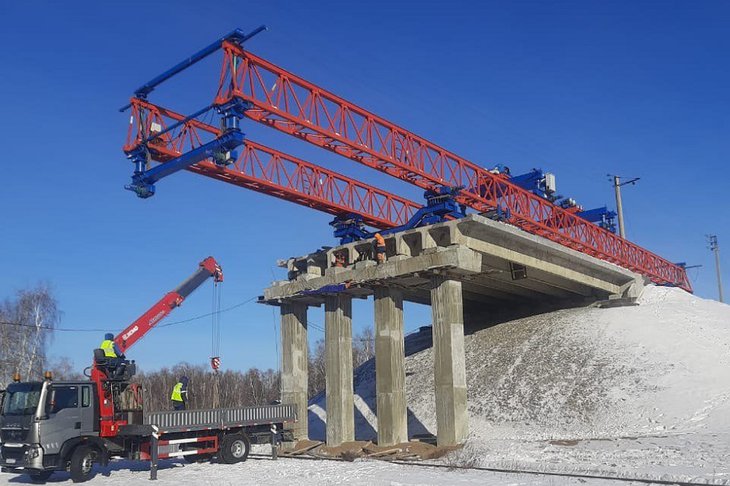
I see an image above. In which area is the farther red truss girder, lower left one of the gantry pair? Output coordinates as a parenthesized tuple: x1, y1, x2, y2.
(124, 98, 420, 229)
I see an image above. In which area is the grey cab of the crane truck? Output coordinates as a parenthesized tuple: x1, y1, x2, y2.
(0, 380, 100, 479)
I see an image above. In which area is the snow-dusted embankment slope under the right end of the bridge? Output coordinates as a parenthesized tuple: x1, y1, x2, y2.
(458, 287, 730, 440)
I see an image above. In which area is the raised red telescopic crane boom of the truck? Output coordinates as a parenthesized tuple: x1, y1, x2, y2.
(114, 257, 223, 353)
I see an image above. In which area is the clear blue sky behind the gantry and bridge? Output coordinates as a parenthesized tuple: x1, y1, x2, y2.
(0, 1, 730, 369)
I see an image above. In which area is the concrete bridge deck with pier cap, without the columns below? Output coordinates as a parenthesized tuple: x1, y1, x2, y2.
(261, 214, 644, 305)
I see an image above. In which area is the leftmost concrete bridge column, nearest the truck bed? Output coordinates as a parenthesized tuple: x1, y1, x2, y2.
(281, 303, 309, 439)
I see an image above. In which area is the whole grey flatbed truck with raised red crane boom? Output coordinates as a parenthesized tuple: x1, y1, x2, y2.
(0, 257, 296, 482)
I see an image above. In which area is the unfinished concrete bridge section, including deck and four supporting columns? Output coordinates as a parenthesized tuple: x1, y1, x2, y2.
(260, 214, 645, 445)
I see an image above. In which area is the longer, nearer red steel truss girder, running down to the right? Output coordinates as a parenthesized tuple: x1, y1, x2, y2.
(216, 42, 692, 292)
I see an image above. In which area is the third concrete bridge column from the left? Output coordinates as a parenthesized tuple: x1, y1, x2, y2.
(375, 287, 408, 446)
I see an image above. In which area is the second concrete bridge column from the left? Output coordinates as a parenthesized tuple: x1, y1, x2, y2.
(324, 294, 355, 446)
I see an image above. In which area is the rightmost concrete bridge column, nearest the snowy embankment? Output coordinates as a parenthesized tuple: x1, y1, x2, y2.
(431, 276, 469, 446)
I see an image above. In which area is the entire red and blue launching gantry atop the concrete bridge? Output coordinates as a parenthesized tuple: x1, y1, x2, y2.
(122, 26, 692, 292)
